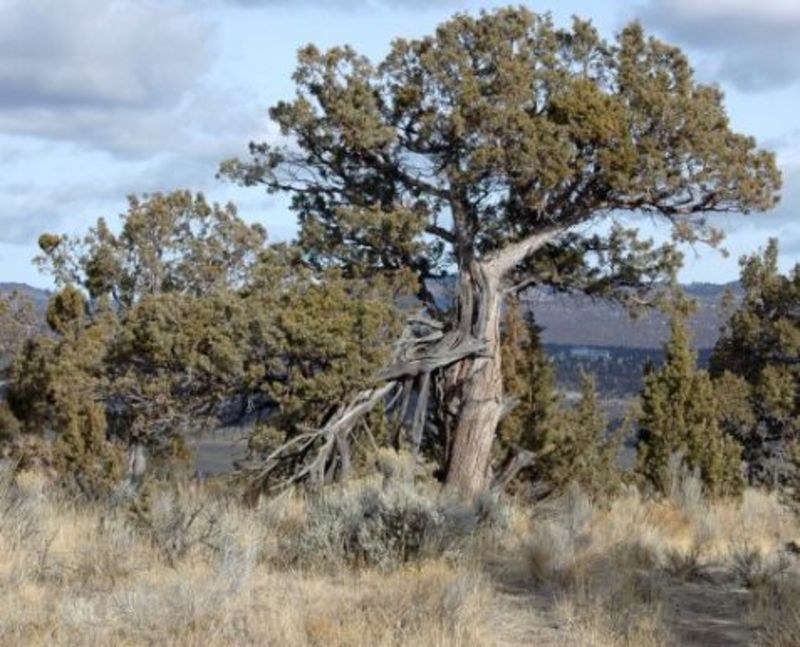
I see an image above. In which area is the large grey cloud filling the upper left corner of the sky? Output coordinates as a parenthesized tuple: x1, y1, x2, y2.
(0, 0, 212, 153)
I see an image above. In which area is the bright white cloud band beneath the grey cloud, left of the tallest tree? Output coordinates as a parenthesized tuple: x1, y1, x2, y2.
(0, 95, 270, 243)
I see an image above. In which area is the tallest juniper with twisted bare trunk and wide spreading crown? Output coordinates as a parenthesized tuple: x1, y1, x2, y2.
(222, 8, 780, 492)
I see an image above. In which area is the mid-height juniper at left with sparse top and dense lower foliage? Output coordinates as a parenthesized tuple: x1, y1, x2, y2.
(11, 191, 265, 460)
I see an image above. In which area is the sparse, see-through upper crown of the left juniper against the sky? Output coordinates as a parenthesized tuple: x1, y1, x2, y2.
(36, 191, 266, 309)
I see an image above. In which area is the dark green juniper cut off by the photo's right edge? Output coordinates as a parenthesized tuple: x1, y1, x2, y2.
(711, 239, 800, 492)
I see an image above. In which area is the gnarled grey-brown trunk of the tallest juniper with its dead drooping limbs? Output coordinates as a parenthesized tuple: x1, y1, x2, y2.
(241, 230, 557, 503)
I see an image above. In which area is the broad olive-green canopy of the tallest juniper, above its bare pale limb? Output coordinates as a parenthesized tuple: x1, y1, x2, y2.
(223, 9, 780, 284)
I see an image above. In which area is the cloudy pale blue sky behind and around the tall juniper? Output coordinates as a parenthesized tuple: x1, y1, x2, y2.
(0, 0, 800, 287)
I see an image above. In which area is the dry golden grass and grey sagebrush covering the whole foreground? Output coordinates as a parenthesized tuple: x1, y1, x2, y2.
(0, 460, 800, 647)
